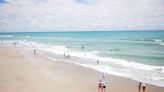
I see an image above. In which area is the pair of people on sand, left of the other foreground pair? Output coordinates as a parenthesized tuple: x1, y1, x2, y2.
(98, 73, 106, 92)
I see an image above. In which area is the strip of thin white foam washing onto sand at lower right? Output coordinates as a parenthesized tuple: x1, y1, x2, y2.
(79, 64, 164, 87)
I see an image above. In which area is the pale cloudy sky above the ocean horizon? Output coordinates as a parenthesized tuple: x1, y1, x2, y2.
(0, 0, 164, 32)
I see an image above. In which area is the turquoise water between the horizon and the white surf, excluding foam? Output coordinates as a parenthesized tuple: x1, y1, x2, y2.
(0, 31, 164, 65)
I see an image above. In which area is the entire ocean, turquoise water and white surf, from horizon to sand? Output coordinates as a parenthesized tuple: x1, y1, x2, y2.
(0, 31, 164, 87)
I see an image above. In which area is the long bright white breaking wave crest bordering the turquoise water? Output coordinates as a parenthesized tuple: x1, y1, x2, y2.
(40, 41, 163, 71)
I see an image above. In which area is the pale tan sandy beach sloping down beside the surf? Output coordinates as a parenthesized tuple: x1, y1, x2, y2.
(0, 47, 164, 92)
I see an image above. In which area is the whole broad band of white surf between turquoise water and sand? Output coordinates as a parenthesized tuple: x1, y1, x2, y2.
(0, 41, 164, 87)
